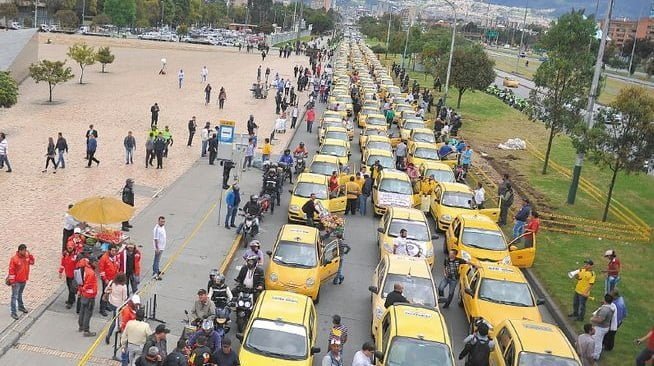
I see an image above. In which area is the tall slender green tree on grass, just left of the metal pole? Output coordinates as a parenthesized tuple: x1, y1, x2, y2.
(529, 10, 596, 174)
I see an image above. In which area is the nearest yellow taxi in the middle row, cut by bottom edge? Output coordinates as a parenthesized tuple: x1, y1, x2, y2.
(375, 304, 456, 366)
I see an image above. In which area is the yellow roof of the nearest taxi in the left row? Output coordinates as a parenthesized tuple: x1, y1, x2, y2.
(256, 290, 311, 324)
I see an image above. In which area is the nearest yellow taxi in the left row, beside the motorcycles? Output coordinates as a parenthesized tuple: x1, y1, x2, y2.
(236, 290, 320, 366)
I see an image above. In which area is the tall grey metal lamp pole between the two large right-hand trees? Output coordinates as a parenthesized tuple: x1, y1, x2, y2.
(568, 0, 614, 205)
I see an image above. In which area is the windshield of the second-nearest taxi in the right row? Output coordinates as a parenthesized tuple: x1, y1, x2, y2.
(478, 278, 534, 307)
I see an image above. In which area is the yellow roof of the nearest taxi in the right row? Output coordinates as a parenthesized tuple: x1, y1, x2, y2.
(506, 319, 577, 359)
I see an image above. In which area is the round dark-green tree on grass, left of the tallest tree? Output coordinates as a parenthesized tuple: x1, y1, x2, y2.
(436, 44, 495, 108)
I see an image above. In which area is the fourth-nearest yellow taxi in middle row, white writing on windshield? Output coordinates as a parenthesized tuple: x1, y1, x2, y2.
(372, 169, 419, 215)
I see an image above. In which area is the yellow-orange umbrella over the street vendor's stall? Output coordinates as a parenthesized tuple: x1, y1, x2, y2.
(68, 196, 134, 224)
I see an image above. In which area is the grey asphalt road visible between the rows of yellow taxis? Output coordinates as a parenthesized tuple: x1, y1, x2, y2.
(227, 99, 553, 365)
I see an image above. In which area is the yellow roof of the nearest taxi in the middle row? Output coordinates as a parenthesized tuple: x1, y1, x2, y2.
(388, 304, 450, 345)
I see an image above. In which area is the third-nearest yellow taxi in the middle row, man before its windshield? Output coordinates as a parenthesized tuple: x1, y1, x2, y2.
(377, 207, 437, 267)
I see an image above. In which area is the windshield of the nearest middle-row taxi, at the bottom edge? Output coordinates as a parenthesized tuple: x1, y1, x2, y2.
(386, 337, 452, 366)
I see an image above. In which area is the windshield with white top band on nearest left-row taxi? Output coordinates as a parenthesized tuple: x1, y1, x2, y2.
(244, 319, 308, 360)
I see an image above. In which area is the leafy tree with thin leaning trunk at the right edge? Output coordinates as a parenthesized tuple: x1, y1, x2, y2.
(588, 86, 654, 221)
